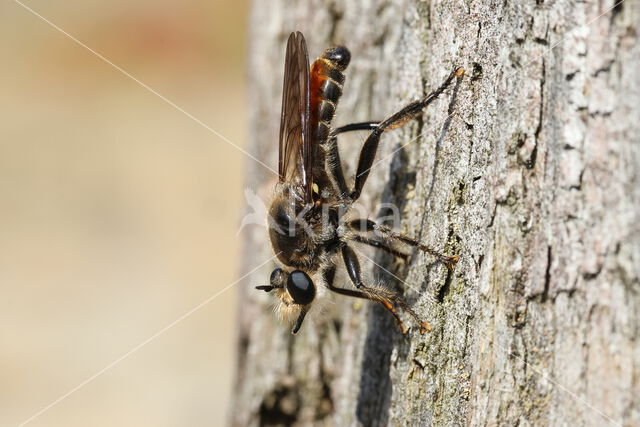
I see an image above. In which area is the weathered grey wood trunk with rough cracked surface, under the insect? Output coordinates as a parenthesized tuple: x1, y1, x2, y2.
(231, 0, 640, 425)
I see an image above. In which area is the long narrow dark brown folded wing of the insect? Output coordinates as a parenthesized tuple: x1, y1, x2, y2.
(278, 32, 313, 203)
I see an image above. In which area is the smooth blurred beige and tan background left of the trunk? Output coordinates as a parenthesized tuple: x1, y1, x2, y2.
(0, 0, 247, 426)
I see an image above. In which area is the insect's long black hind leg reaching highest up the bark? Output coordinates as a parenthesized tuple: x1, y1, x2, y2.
(350, 68, 464, 201)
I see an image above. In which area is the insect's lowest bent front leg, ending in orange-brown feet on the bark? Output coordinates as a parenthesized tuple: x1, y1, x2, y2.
(334, 245, 431, 334)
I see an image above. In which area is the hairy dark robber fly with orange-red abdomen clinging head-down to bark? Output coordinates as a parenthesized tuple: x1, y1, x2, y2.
(256, 32, 464, 334)
